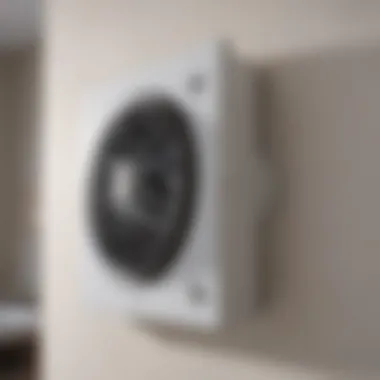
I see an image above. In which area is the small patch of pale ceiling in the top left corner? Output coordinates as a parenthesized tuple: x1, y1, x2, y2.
(0, 0, 40, 48)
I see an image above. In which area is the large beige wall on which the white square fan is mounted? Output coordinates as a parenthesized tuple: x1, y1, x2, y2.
(42, 0, 380, 380)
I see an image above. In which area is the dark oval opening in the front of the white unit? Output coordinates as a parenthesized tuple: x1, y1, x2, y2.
(89, 99, 196, 279)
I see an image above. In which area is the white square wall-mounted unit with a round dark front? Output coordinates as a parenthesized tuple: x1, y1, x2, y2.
(81, 42, 270, 329)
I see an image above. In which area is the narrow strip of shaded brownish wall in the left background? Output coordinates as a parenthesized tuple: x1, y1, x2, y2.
(0, 47, 38, 300)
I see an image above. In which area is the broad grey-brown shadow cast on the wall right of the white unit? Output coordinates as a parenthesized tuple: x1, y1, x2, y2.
(141, 43, 380, 374)
